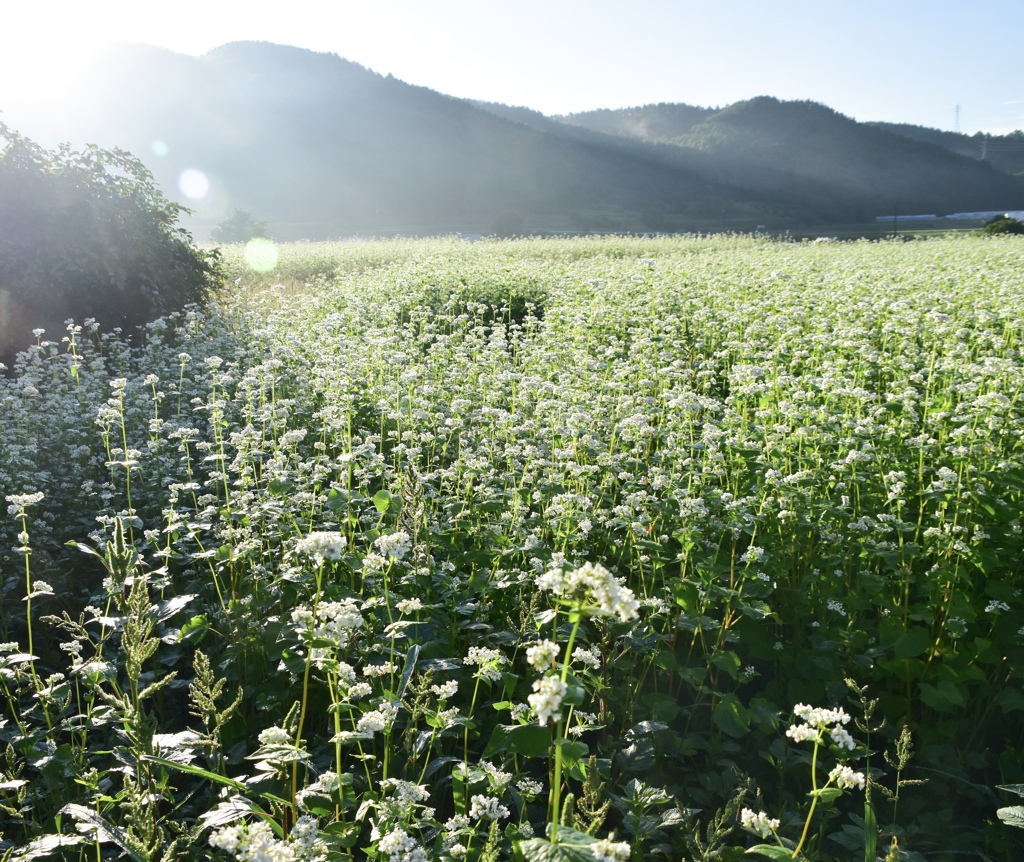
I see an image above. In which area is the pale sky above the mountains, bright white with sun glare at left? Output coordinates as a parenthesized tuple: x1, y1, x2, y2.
(6, 0, 1024, 134)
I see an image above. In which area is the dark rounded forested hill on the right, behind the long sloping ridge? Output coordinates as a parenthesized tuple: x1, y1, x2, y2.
(564, 96, 1021, 221)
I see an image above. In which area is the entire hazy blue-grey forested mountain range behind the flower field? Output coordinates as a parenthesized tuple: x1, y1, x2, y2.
(8, 42, 1024, 240)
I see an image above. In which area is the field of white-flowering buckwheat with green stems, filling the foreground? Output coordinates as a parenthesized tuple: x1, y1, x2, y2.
(0, 231, 1024, 862)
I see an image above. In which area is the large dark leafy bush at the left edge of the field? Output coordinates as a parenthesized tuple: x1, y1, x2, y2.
(0, 123, 220, 364)
